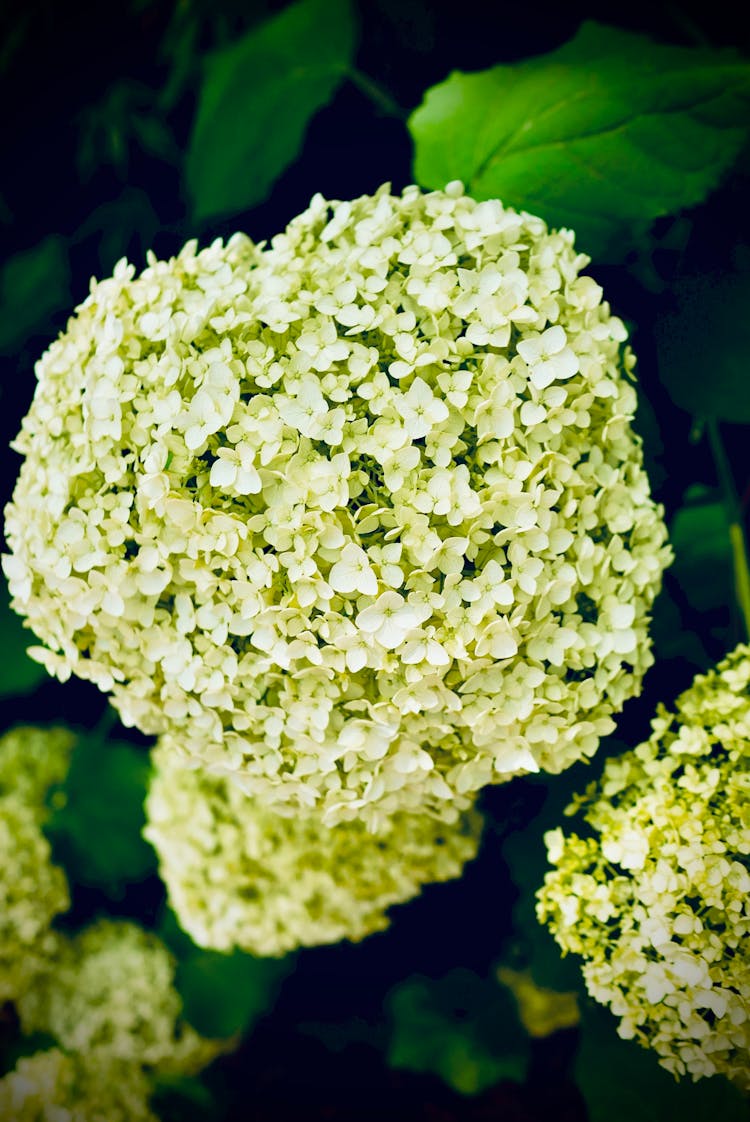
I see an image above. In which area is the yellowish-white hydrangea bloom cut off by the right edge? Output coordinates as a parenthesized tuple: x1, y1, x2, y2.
(538, 646, 750, 1089)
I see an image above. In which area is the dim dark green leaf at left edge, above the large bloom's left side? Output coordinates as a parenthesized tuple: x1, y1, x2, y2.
(0, 233, 71, 351)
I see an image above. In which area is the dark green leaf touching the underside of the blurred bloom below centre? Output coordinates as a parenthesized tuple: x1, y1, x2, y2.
(159, 909, 295, 1039)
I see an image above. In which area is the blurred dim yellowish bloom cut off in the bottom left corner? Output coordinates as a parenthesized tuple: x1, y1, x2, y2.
(0, 1048, 158, 1122)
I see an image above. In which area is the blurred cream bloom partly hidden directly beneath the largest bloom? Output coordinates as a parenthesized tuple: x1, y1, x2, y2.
(145, 749, 481, 956)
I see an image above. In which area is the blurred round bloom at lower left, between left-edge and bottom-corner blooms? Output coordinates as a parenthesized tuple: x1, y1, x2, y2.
(18, 919, 222, 1073)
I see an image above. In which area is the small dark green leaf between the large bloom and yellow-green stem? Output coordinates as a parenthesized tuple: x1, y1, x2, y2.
(669, 488, 734, 611)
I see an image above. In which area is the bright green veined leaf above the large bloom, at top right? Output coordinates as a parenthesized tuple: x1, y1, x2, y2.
(409, 22, 750, 260)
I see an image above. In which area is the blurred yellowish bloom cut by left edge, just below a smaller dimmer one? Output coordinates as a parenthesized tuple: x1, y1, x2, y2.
(0, 794, 70, 1005)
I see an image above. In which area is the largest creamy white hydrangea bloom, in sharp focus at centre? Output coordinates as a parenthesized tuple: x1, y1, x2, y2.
(4, 184, 669, 828)
